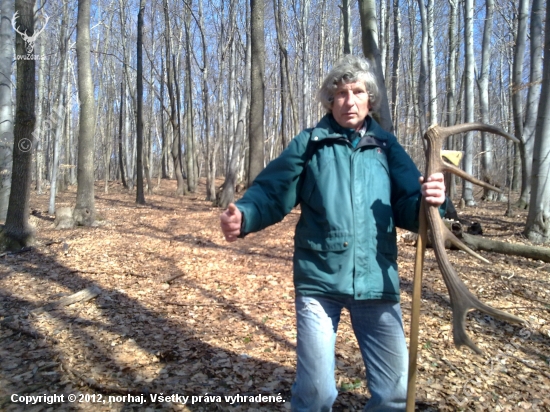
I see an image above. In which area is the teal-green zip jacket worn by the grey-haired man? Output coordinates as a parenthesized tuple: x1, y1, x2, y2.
(236, 115, 444, 301)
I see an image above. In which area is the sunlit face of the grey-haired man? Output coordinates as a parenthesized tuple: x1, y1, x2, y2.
(332, 81, 370, 130)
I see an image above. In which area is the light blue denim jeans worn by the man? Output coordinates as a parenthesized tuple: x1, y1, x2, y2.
(291, 295, 408, 412)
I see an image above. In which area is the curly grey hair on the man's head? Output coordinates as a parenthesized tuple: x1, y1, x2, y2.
(317, 54, 380, 113)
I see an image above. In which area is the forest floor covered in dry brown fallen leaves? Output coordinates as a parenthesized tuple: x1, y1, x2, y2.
(0, 181, 550, 411)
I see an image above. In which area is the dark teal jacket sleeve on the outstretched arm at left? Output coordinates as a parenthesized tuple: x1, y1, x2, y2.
(235, 130, 310, 237)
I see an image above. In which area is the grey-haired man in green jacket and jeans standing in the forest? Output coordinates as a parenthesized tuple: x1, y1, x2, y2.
(220, 56, 445, 412)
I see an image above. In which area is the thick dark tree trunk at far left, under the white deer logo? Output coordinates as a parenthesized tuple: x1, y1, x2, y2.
(0, 0, 36, 250)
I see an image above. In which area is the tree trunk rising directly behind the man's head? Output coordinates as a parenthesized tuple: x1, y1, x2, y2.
(359, 0, 393, 132)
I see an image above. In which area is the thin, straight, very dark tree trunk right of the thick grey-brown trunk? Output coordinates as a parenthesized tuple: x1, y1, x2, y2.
(136, 0, 145, 205)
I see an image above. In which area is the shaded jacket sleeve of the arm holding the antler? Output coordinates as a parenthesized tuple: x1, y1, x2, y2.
(388, 136, 447, 232)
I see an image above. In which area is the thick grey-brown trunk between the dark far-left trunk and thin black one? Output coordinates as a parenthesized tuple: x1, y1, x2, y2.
(74, 0, 96, 226)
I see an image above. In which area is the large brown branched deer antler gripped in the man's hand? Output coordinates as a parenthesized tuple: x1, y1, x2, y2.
(423, 123, 525, 354)
